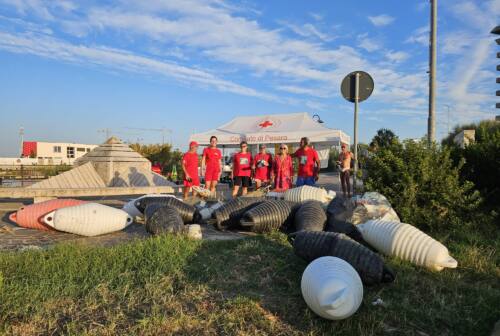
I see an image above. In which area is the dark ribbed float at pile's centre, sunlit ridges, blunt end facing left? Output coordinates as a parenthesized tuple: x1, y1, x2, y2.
(240, 200, 295, 233)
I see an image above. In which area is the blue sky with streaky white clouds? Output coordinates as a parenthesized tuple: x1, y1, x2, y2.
(0, 0, 500, 156)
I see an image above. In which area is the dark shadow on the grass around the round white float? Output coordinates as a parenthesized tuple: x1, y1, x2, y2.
(185, 234, 500, 335)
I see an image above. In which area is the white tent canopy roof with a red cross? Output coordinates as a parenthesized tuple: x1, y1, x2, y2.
(190, 112, 351, 145)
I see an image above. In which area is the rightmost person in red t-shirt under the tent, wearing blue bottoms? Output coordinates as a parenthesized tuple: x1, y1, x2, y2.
(293, 137, 321, 187)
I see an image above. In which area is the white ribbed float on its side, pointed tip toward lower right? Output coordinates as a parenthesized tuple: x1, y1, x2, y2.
(358, 220, 458, 271)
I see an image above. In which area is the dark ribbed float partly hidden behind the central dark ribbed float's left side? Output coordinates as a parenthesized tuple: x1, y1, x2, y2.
(213, 197, 263, 230)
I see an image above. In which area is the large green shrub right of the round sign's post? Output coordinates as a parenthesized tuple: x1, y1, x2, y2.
(364, 140, 481, 231)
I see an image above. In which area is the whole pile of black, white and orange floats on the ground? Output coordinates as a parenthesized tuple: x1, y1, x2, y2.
(9, 186, 458, 320)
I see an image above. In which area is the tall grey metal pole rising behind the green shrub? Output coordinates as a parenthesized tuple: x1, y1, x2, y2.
(427, 0, 437, 143)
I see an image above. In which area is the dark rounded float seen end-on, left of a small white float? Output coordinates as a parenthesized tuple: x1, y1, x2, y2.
(144, 203, 186, 235)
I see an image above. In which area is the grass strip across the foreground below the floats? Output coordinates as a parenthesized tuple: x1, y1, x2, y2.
(0, 233, 500, 335)
